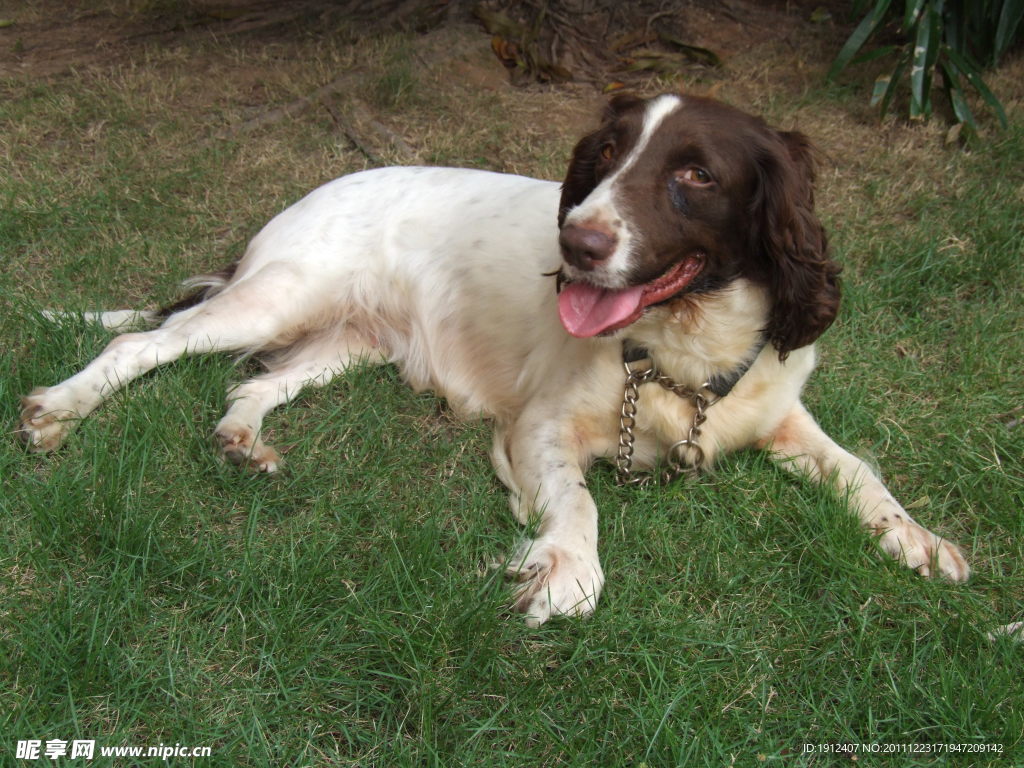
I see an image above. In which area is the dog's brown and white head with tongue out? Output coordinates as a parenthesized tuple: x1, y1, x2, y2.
(558, 95, 840, 357)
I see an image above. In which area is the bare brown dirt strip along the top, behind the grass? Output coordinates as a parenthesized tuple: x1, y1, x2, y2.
(0, 0, 849, 77)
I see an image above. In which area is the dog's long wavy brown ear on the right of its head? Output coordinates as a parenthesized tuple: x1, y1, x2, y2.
(754, 131, 840, 359)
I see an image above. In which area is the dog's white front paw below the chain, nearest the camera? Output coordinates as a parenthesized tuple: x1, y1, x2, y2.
(508, 537, 604, 627)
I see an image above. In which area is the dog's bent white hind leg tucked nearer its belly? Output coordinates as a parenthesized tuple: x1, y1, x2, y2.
(214, 333, 383, 472)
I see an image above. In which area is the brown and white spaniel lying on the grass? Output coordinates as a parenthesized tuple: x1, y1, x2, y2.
(19, 94, 970, 626)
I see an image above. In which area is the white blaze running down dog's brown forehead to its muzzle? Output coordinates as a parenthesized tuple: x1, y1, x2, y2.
(565, 94, 682, 288)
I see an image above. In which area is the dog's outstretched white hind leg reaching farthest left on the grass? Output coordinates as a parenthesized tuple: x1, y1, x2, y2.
(18, 264, 323, 452)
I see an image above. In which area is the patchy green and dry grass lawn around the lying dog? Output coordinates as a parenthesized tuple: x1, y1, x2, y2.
(0, 4, 1024, 768)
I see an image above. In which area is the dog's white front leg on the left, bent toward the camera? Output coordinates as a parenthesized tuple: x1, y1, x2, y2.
(495, 412, 604, 627)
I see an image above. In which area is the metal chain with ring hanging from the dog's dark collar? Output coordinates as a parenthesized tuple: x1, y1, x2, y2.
(615, 362, 720, 485)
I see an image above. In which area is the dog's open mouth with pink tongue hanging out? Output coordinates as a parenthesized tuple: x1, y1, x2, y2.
(558, 253, 705, 339)
